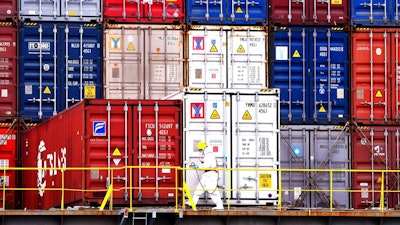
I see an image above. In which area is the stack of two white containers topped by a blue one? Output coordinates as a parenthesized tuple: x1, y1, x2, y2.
(183, 0, 279, 205)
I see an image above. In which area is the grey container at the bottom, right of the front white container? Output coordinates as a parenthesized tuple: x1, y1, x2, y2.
(280, 125, 351, 209)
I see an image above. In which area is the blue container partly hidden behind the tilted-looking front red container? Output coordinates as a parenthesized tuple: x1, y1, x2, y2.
(18, 22, 103, 122)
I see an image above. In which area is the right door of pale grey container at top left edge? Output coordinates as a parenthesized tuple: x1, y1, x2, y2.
(61, 0, 102, 21)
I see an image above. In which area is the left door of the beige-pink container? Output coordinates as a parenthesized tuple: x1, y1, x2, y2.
(104, 28, 144, 99)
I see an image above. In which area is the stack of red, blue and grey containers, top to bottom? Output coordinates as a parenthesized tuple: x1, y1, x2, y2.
(269, 0, 350, 208)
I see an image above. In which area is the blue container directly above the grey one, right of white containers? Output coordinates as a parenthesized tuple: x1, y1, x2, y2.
(269, 27, 350, 124)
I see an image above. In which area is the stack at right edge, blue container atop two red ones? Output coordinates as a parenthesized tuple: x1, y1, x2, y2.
(351, 0, 400, 208)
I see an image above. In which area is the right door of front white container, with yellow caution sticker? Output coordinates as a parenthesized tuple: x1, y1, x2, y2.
(232, 91, 280, 204)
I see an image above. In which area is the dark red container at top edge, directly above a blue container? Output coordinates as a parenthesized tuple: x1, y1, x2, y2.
(269, 0, 350, 26)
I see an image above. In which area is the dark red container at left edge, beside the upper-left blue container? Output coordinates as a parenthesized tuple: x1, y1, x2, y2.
(0, 22, 18, 121)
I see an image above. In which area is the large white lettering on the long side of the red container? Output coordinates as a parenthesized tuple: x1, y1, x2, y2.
(36, 140, 67, 197)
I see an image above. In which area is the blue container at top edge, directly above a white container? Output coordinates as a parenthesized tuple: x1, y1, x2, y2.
(186, 0, 268, 25)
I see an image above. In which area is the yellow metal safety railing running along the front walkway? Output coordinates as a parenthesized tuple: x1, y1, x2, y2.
(0, 166, 400, 212)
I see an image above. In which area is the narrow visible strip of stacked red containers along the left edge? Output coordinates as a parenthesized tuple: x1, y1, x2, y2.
(0, 0, 19, 210)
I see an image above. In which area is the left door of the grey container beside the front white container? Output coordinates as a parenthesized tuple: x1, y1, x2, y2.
(280, 126, 311, 207)
